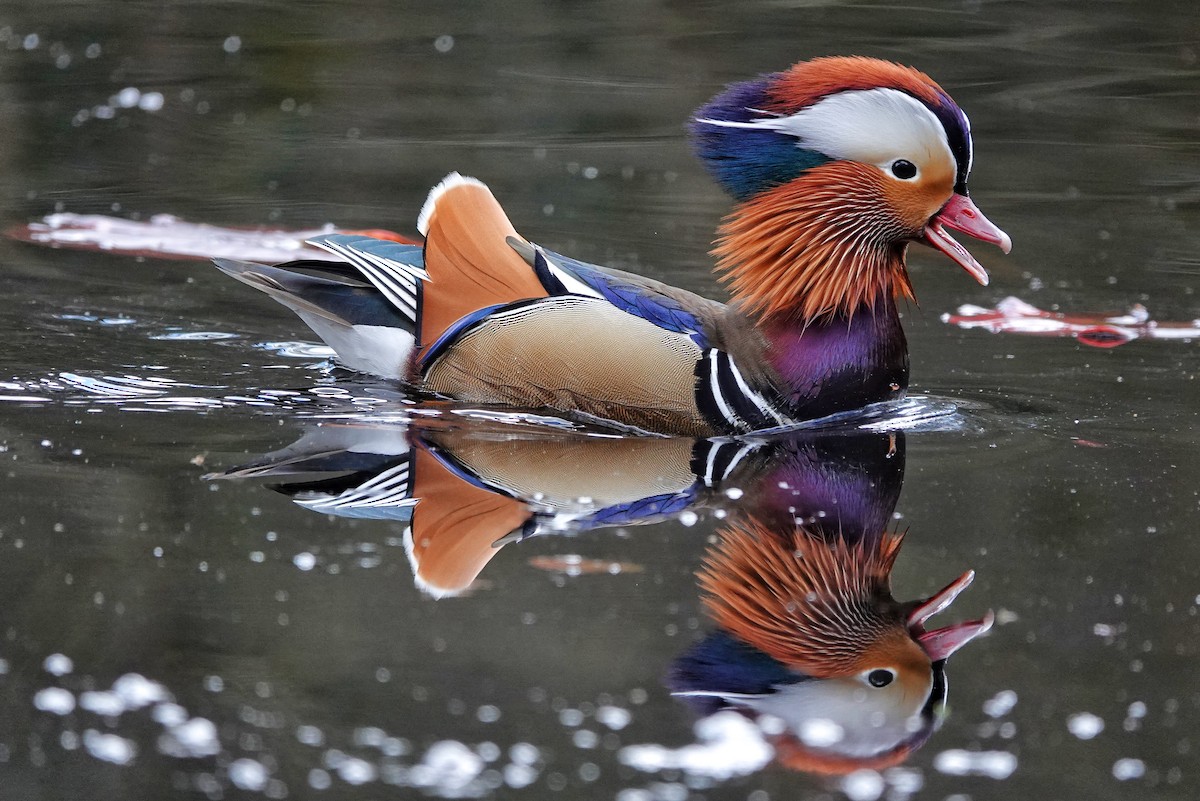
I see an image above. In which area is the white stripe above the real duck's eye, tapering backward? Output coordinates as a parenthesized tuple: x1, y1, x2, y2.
(697, 89, 955, 169)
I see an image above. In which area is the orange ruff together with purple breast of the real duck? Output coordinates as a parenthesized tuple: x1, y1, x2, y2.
(713, 162, 912, 420)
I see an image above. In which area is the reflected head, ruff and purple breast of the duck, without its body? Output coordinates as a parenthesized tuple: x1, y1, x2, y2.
(667, 434, 992, 773)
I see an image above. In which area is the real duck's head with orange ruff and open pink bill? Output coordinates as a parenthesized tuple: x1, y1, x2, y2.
(691, 56, 1012, 320)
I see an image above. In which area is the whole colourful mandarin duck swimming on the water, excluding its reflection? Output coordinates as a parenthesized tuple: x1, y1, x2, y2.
(216, 58, 1010, 436)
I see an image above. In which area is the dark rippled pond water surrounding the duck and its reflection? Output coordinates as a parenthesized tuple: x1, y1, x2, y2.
(0, 1, 1200, 801)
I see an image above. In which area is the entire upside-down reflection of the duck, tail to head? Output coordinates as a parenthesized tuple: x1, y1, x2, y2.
(220, 423, 992, 773)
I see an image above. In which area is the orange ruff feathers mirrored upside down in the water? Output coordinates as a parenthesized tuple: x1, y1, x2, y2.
(698, 520, 910, 679)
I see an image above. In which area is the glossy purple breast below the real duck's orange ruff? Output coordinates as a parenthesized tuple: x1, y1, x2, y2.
(760, 296, 908, 420)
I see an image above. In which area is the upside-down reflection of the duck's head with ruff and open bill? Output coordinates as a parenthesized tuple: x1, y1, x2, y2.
(673, 522, 992, 772)
